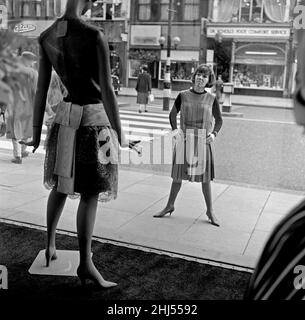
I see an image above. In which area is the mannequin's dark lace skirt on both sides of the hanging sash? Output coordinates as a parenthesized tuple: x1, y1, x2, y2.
(44, 123, 118, 201)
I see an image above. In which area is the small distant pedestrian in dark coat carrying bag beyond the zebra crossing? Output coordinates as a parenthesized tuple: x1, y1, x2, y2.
(136, 65, 151, 113)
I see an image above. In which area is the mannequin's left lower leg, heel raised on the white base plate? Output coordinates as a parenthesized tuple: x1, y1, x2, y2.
(45, 189, 67, 267)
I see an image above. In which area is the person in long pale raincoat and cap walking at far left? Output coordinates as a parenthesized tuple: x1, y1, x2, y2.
(6, 51, 38, 164)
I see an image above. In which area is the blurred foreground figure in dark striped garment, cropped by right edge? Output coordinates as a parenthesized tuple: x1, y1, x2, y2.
(245, 25, 305, 300)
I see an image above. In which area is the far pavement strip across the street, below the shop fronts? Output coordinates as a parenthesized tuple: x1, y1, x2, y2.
(119, 87, 293, 109)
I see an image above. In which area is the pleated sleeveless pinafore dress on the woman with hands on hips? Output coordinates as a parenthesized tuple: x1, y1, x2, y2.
(171, 90, 215, 182)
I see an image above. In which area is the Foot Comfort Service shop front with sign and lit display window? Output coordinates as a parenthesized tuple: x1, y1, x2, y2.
(207, 23, 292, 97)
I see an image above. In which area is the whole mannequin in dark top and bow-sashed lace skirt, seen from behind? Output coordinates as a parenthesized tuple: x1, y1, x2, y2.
(19, 0, 130, 288)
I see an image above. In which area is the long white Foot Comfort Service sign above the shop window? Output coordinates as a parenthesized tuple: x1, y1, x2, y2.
(207, 27, 290, 39)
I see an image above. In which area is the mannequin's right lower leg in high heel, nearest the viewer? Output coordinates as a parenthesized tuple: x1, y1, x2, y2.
(77, 194, 117, 288)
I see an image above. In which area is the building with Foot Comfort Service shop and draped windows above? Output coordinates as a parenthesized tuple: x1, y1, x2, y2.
(203, 0, 296, 97)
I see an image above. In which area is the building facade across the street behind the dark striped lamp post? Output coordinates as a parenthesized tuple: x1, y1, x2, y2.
(127, 0, 209, 90)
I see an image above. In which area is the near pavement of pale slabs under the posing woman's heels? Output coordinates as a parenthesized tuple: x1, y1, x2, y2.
(0, 150, 303, 268)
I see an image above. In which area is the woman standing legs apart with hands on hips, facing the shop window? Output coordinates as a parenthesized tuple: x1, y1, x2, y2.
(154, 64, 222, 226)
